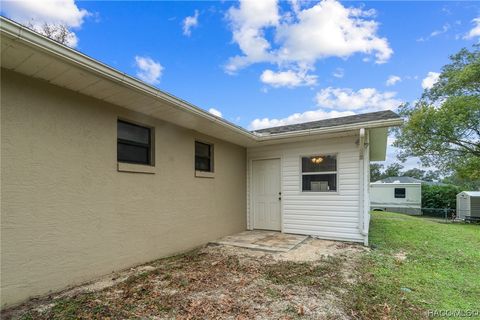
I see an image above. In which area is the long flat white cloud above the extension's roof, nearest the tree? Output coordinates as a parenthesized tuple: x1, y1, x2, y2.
(315, 87, 402, 113)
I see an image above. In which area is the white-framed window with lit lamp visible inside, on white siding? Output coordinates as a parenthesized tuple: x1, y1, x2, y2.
(302, 155, 337, 192)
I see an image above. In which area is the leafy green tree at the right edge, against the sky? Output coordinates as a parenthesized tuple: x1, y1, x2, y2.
(394, 45, 480, 180)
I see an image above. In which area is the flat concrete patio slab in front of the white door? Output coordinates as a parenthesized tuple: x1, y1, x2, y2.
(212, 230, 308, 252)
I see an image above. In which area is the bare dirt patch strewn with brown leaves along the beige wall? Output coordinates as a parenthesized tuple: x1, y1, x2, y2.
(2, 239, 363, 319)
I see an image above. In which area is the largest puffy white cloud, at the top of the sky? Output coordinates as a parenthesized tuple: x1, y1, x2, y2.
(276, 0, 392, 63)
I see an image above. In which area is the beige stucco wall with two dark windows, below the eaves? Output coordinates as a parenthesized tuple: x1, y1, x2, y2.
(1, 70, 246, 307)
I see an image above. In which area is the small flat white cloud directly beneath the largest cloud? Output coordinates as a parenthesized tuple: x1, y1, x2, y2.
(260, 69, 317, 88)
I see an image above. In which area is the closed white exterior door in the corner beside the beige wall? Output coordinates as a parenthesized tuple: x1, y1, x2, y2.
(252, 159, 281, 231)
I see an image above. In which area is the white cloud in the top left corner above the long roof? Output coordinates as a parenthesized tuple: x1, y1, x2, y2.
(2, 0, 90, 47)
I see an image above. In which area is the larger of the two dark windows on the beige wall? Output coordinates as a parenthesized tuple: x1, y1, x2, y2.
(117, 120, 152, 165)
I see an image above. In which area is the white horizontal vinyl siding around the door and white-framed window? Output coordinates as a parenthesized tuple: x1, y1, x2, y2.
(247, 135, 365, 242)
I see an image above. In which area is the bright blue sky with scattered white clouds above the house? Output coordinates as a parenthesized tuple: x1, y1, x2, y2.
(2, 0, 480, 167)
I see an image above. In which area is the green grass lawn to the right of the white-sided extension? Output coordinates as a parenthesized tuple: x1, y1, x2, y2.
(351, 212, 480, 319)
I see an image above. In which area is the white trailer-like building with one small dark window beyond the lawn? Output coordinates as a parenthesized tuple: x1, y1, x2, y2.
(370, 177, 423, 215)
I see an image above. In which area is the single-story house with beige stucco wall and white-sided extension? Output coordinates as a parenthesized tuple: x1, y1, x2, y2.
(0, 18, 402, 307)
